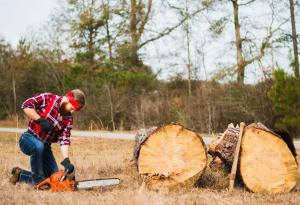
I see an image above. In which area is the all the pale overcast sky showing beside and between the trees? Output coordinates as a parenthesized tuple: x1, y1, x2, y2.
(0, 0, 299, 83)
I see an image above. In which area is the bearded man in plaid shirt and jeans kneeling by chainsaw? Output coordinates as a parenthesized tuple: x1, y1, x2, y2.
(10, 89, 85, 185)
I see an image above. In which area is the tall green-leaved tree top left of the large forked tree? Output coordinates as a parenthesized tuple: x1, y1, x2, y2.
(65, 0, 107, 64)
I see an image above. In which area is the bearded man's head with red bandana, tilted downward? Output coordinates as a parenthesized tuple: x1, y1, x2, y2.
(59, 89, 85, 115)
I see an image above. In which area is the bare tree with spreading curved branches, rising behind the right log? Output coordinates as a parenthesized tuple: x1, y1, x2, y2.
(212, 0, 288, 84)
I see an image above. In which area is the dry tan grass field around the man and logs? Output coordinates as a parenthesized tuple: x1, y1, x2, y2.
(0, 133, 300, 205)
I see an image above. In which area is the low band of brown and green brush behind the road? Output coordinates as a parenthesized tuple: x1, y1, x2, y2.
(0, 38, 300, 134)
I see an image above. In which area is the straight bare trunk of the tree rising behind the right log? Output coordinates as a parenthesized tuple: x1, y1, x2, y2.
(232, 0, 245, 84)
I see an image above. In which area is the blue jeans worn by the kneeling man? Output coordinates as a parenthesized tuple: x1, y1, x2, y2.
(19, 131, 58, 185)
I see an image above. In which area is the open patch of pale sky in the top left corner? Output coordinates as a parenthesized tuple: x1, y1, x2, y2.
(0, 0, 57, 45)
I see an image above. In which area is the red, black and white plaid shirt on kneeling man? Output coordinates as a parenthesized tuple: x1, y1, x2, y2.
(21, 93, 73, 145)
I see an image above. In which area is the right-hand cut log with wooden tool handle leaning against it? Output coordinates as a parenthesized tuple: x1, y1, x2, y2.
(209, 123, 298, 193)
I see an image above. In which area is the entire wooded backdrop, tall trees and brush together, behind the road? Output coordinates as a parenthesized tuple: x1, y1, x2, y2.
(0, 0, 300, 136)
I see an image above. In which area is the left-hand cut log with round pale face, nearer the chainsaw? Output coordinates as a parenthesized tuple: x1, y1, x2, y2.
(134, 123, 208, 189)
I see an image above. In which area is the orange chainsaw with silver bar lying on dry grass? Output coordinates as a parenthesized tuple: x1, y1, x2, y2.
(35, 170, 120, 192)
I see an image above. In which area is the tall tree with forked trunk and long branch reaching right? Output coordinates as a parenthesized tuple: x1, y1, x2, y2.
(119, 0, 204, 71)
